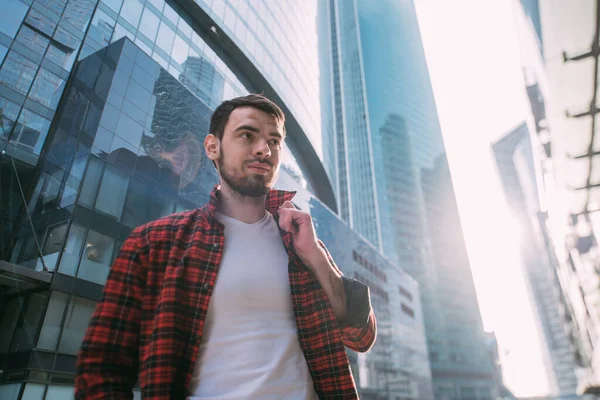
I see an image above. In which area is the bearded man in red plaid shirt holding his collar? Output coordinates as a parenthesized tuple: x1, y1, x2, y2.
(76, 95, 376, 400)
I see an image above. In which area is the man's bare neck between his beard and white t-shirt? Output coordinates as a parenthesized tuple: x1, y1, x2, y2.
(217, 182, 266, 224)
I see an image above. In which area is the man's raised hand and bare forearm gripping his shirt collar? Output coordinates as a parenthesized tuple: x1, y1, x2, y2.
(279, 201, 348, 322)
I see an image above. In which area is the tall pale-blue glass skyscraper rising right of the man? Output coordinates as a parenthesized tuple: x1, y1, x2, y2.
(320, 0, 498, 399)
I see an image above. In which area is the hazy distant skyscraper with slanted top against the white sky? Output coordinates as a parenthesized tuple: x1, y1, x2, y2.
(493, 124, 577, 398)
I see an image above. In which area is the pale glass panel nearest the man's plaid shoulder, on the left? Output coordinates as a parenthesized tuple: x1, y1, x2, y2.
(77, 230, 115, 285)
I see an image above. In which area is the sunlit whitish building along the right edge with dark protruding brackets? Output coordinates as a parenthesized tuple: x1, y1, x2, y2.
(515, 0, 600, 396)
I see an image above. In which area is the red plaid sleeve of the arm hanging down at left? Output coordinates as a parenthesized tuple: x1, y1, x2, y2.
(75, 227, 148, 400)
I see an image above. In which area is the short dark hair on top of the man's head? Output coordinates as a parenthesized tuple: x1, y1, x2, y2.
(208, 94, 285, 140)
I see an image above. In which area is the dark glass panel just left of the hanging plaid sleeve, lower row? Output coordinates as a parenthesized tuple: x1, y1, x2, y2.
(55, 296, 96, 354)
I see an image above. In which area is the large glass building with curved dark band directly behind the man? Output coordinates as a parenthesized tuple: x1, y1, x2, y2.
(0, 0, 433, 400)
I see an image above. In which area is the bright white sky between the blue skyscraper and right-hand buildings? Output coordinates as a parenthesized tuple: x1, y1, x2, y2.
(415, 0, 548, 396)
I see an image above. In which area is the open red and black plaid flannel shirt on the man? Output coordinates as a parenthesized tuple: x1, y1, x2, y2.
(75, 188, 376, 400)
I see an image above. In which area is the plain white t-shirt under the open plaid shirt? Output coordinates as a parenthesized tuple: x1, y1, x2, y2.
(188, 212, 317, 400)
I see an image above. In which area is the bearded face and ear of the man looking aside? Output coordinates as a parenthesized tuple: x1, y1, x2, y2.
(205, 107, 284, 197)
